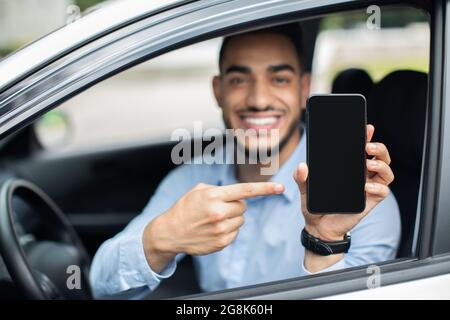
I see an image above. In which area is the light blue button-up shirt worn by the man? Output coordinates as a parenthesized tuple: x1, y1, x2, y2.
(90, 134, 400, 297)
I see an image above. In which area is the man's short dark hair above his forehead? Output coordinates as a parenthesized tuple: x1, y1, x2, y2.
(219, 22, 305, 72)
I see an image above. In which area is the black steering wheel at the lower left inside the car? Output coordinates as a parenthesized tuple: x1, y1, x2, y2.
(0, 179, 92, 300)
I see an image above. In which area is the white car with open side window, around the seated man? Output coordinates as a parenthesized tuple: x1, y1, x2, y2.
(0, 0, 450, 299)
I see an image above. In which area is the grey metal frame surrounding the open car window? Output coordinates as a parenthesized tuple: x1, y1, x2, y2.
(0, 0, 442, 299)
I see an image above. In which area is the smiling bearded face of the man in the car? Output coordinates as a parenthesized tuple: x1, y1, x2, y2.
(213, 33, 309, 156)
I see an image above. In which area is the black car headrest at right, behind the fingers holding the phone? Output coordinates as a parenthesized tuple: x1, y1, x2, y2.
(367, 70, 428, 170)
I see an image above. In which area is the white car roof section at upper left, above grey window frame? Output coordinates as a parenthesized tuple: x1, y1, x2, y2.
(0, 0, 187, 91)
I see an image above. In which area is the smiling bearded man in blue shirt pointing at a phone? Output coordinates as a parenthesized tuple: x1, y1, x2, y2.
(91, 24, 400, 296)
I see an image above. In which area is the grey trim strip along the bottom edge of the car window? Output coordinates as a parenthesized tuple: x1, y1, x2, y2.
(177, 254, 450, 300)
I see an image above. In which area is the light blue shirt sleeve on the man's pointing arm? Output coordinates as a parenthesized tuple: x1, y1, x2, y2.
(89, 166, 198, 297)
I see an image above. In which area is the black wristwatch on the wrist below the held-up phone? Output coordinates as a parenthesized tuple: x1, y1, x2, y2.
(301, 228, 351, 256)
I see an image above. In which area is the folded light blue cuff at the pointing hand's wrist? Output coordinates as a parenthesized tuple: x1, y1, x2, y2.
(119, 224, 177, 290)
